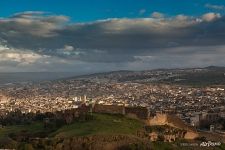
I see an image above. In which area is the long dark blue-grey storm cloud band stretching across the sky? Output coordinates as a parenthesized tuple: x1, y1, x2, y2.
(0, 12, 225, 63)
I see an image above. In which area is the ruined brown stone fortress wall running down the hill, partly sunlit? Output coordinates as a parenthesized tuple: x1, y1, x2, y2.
(87, 104, 199, 141)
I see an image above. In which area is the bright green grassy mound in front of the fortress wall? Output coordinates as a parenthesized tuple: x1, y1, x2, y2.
(51, 114, 144, 137)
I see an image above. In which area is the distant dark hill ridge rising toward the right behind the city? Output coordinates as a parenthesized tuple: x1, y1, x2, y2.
(71, 66, 225, 86)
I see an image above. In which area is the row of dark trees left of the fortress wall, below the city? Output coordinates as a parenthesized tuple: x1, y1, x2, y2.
(0, 106, 90, 126)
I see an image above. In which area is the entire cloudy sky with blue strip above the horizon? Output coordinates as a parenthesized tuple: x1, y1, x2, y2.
(0, 0, 225, 73)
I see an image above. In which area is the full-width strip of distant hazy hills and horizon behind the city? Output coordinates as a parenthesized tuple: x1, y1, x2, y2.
(0, 66, 225, 86)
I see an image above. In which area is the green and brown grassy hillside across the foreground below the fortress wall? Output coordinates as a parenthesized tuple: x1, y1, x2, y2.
(0, 114, 224, 150)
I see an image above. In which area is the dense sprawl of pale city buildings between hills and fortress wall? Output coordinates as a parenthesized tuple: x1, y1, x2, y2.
(0, 80, 225, 131)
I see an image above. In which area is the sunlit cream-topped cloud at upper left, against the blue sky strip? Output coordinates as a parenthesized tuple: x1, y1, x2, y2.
(0, 11, 68, 37)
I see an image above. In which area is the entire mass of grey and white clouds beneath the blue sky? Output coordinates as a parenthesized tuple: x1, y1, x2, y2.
(0, 12, 225, 70)
